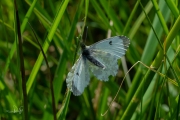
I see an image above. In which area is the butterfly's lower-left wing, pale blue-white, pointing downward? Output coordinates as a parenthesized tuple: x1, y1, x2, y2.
(66, 56, 90, 96)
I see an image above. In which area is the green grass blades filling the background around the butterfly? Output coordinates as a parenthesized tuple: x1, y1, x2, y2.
(0, 0, 180, 120)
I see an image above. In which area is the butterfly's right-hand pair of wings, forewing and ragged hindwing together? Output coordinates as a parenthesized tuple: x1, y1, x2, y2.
(89, 36, 130, 81)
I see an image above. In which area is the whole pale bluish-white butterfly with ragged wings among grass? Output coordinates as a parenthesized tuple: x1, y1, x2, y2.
(66, 36, 130, 96)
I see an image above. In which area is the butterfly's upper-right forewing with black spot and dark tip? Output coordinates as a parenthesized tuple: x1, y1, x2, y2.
(89, 36, 130, 58)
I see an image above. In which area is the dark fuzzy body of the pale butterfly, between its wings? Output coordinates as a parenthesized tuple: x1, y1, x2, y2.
(82, 49, 105, 69)
